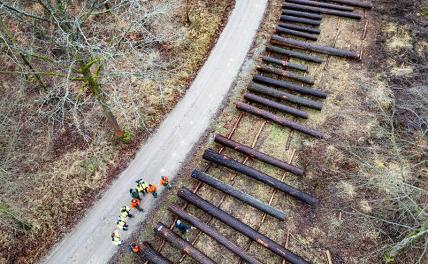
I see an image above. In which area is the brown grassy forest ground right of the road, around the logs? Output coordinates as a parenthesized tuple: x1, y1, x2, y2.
(111, 0, 428, 264)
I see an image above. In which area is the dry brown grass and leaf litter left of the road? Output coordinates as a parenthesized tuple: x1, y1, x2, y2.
(0, 0, 231, 263)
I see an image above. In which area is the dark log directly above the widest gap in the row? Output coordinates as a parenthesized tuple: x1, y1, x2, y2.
(235, 102, 324, 138)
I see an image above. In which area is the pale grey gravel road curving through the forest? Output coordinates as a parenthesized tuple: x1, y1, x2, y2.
(41, 0, 267, 264)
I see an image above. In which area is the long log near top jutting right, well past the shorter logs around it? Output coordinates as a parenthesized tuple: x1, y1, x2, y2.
(272, 35, 360, 59)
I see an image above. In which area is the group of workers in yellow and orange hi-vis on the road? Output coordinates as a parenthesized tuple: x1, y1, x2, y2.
(111, 176, 171, 246)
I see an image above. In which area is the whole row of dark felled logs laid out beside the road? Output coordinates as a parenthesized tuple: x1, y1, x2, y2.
(143, 0, 372, 264)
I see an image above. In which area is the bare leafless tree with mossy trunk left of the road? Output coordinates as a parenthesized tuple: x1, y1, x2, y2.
(0, 0, 182, 138)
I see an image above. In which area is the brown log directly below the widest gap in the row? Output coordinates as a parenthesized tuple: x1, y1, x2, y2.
(214, 134, 303, 176)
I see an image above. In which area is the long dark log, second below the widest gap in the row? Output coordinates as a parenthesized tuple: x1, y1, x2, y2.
(203, 149, 319, 206)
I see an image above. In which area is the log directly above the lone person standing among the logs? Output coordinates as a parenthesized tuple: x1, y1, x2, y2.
(169, 205, 262, 264)
